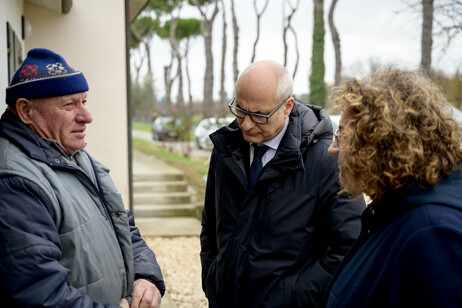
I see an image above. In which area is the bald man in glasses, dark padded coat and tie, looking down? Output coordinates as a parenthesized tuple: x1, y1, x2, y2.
(201, 61, 365, 307)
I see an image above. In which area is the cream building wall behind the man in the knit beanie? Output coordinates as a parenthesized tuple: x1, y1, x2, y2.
(24, 0, 129, 208)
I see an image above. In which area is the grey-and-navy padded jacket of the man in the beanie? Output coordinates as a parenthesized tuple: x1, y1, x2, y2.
(0, 111, 165, 308)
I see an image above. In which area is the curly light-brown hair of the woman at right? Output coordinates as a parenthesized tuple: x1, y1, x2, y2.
(330, 68, 462, 202)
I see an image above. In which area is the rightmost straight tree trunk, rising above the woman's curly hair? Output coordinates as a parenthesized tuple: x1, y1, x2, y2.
(420, 0, 433, 74)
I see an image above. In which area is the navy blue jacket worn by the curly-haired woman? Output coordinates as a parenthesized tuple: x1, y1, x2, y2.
(325, 172, 462, 308)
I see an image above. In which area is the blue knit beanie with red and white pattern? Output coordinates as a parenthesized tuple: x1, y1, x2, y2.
(6, 48, 88, 106)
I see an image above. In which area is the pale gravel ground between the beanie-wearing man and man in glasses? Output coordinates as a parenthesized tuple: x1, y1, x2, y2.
(145, 236, 208, 308)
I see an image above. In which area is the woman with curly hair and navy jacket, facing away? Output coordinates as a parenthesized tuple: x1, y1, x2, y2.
(324, 68, 462, 308)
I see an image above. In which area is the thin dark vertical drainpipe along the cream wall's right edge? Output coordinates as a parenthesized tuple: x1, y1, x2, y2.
(125, 0, 133, 211)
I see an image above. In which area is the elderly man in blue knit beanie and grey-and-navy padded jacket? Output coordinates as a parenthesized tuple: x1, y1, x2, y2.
(0, 49, 165, 308)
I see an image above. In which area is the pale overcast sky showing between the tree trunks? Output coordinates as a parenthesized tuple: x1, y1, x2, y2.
(138, 0, 462, 99)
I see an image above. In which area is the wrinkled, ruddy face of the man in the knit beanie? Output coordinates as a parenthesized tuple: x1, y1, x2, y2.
(30, 92, 93, 154)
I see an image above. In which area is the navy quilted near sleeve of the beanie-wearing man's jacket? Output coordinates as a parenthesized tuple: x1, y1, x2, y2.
(0, 177, 120, 308)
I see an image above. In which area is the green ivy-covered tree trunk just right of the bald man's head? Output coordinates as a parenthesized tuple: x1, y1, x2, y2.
(310, 0, 326, 107)
